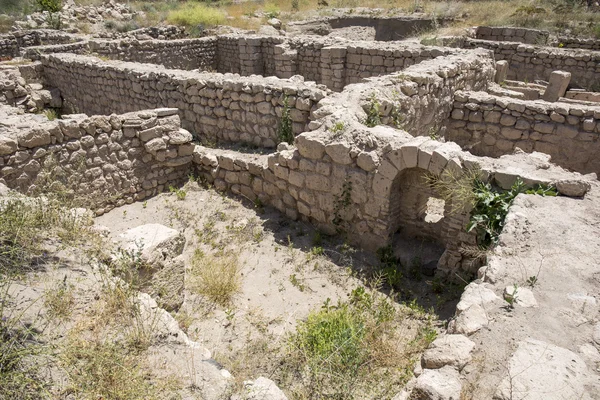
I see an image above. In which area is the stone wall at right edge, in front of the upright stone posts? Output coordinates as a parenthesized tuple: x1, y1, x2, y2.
(445, 92, 600, 174)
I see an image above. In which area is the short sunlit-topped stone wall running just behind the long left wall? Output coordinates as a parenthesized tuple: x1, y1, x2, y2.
(89, 37, 217, 71)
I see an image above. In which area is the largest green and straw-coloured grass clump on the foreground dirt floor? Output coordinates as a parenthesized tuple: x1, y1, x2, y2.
(284, 287, 435, 399)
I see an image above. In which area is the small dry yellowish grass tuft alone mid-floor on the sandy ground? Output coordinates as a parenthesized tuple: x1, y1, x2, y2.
(191, 250, 241, 307)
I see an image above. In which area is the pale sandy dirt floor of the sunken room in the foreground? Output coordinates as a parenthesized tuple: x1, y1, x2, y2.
(0, 181, 461, 399)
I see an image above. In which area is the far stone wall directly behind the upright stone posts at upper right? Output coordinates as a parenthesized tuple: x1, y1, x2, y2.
(456, 38, 600, 91)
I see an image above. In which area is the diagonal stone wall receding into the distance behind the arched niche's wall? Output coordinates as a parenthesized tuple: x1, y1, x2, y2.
(311, 50, 495, 136)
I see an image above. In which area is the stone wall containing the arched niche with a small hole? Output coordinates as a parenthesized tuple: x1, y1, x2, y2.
(194, 132, 476, 276)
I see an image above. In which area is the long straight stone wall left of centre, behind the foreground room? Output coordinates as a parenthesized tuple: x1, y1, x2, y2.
(42, 54, 327, 147)
